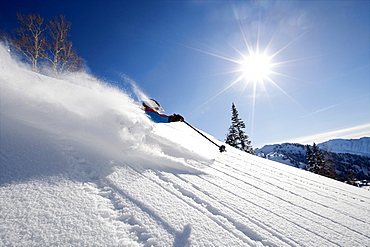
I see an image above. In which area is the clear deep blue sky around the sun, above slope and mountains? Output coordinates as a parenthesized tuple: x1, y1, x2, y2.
(0, 0, 370, 147)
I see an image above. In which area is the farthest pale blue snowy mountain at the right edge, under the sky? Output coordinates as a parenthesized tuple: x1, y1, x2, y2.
(318, 137, 370, 157)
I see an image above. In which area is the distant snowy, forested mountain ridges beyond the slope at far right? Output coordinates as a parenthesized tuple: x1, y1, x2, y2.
(254, 137, 370, 186)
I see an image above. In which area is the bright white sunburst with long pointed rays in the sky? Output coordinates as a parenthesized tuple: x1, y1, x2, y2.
(187, 5, 309, 141)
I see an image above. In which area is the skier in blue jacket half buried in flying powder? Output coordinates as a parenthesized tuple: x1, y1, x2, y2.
(143, 99, 184, 123)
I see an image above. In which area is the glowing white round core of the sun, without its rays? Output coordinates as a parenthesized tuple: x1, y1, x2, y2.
(239, 52, 272, 83)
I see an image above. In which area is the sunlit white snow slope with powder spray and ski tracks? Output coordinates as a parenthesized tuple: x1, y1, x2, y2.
(0, 46, 370, 246)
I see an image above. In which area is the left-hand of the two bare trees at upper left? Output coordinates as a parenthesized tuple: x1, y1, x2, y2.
(12, 13, 46, 71)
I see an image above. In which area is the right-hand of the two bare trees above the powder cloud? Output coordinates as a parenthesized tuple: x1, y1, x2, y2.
(46, 15, 82, 77)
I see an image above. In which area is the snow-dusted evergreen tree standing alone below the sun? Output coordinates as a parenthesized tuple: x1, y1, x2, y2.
(225, 103, 255, 154)
